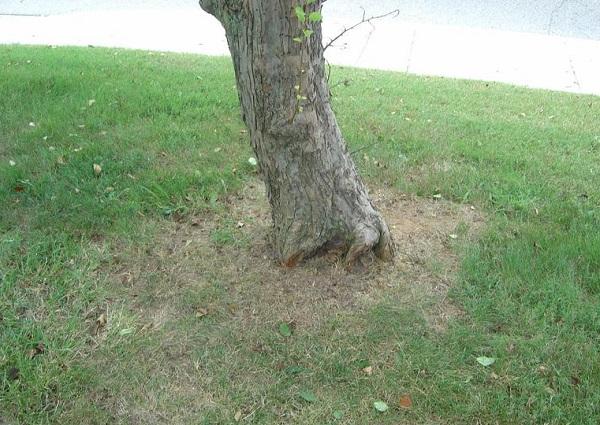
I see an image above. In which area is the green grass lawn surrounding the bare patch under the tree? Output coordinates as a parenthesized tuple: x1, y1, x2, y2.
(0, 47, 600, 424)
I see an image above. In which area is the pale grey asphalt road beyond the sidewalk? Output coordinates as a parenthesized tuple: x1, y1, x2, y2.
(0, 0, 600, 40)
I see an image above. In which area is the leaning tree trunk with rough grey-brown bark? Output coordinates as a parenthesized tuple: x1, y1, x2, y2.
(200, 0, 393, 266)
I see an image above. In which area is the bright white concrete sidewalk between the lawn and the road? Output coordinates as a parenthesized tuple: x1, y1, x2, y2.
(0, 8, 600, 95)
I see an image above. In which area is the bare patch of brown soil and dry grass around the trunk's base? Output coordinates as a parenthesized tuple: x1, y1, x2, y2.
(109, 181, 484, 330)
